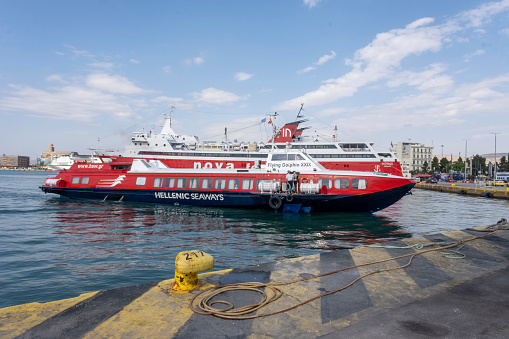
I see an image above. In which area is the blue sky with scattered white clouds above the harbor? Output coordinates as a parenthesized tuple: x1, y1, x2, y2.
(0, 0, 509, 158)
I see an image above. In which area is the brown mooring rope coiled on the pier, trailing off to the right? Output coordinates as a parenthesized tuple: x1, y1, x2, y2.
(189, 219, 509, 320)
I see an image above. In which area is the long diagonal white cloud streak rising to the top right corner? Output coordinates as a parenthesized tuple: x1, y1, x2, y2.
(275, 0, 509, 110)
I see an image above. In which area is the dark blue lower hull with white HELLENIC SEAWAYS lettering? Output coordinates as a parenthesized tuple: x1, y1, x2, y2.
(41, 183, 415, 212)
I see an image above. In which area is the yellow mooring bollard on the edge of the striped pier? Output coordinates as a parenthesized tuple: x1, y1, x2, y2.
(173, 250, 214, 291)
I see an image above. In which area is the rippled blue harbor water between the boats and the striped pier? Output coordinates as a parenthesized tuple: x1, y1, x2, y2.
(0, 171, 509, 307)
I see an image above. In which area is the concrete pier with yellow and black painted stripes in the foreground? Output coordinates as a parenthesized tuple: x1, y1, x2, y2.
(0, 220, 509, 338)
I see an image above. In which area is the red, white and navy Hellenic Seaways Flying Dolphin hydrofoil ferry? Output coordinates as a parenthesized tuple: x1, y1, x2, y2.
(41, 151, 415, 212)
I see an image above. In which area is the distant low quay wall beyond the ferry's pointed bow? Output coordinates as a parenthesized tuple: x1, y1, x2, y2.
(414, 182, 509, 200)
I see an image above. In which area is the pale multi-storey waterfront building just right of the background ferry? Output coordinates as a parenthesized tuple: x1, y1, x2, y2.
(391, 141, 433, 171)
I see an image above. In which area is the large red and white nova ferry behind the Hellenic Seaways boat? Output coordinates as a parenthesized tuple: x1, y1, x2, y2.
(95, 111, 402, 176)
